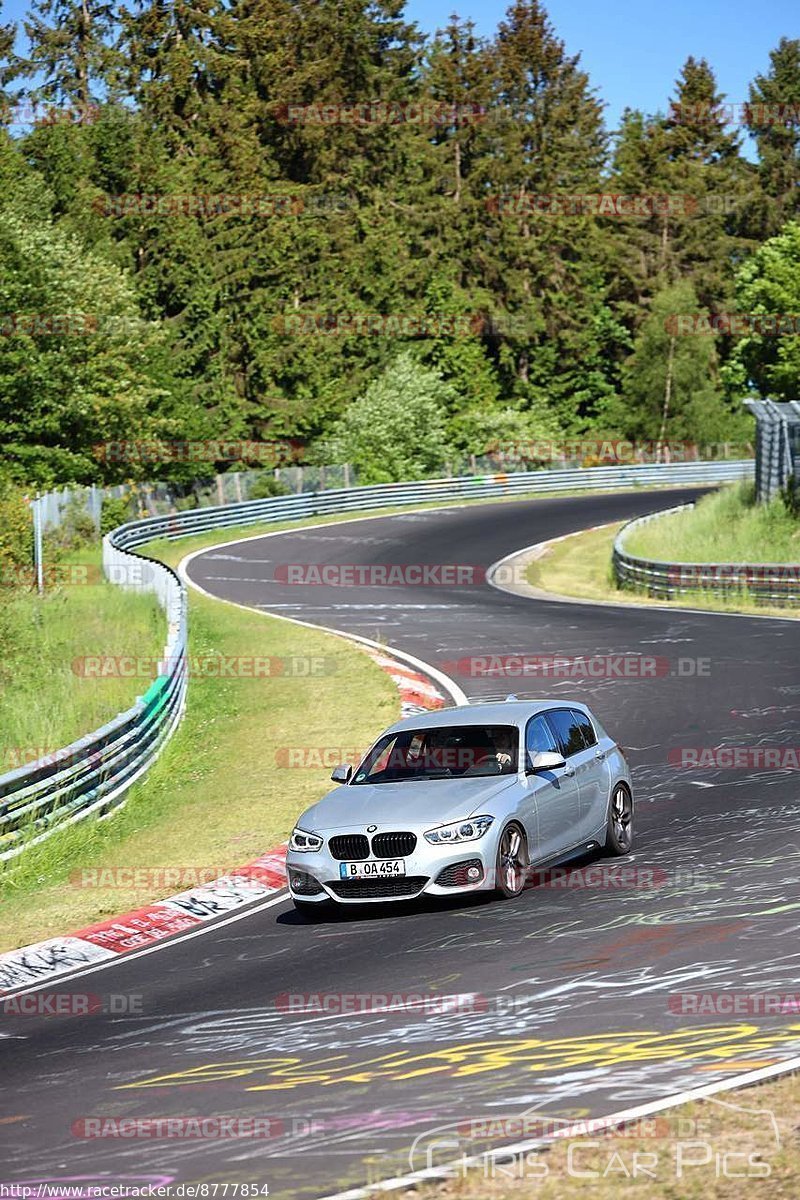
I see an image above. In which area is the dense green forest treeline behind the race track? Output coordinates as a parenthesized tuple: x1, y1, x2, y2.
(0, 0, 800, 487)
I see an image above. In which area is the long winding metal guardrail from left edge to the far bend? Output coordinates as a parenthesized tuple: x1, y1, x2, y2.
(0, 460, 753, 862)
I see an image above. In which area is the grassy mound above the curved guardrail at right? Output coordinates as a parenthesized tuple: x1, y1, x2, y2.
(625, 484, 800, 563)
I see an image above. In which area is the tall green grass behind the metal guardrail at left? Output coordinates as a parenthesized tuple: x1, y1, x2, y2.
(0, 546, 167, 774)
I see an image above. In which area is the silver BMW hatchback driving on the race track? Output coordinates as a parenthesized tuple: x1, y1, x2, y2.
(287, 697, 633, 912)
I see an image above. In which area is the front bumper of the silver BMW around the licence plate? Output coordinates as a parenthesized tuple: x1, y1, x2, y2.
(287, 829, 497, 904)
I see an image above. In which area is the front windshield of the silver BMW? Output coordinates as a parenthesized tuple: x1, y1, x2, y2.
(353, 725, 519, 784)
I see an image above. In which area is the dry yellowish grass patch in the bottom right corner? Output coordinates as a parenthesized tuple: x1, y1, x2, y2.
(415, 1075, 800, 1200)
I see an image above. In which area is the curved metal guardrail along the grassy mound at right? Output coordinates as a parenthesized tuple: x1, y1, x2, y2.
(612, 504, 800, 606)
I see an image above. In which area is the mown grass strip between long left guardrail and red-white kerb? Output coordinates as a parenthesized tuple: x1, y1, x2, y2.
(0, 533, 399, 950)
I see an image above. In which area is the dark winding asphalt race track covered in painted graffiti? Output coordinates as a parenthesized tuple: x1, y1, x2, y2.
(0, 490, 800, 1198)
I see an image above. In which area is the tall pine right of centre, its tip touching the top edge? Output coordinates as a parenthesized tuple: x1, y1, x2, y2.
(474, 0, 606, 427)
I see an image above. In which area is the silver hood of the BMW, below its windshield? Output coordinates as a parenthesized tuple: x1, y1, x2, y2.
(297, 775, 517, 833)
